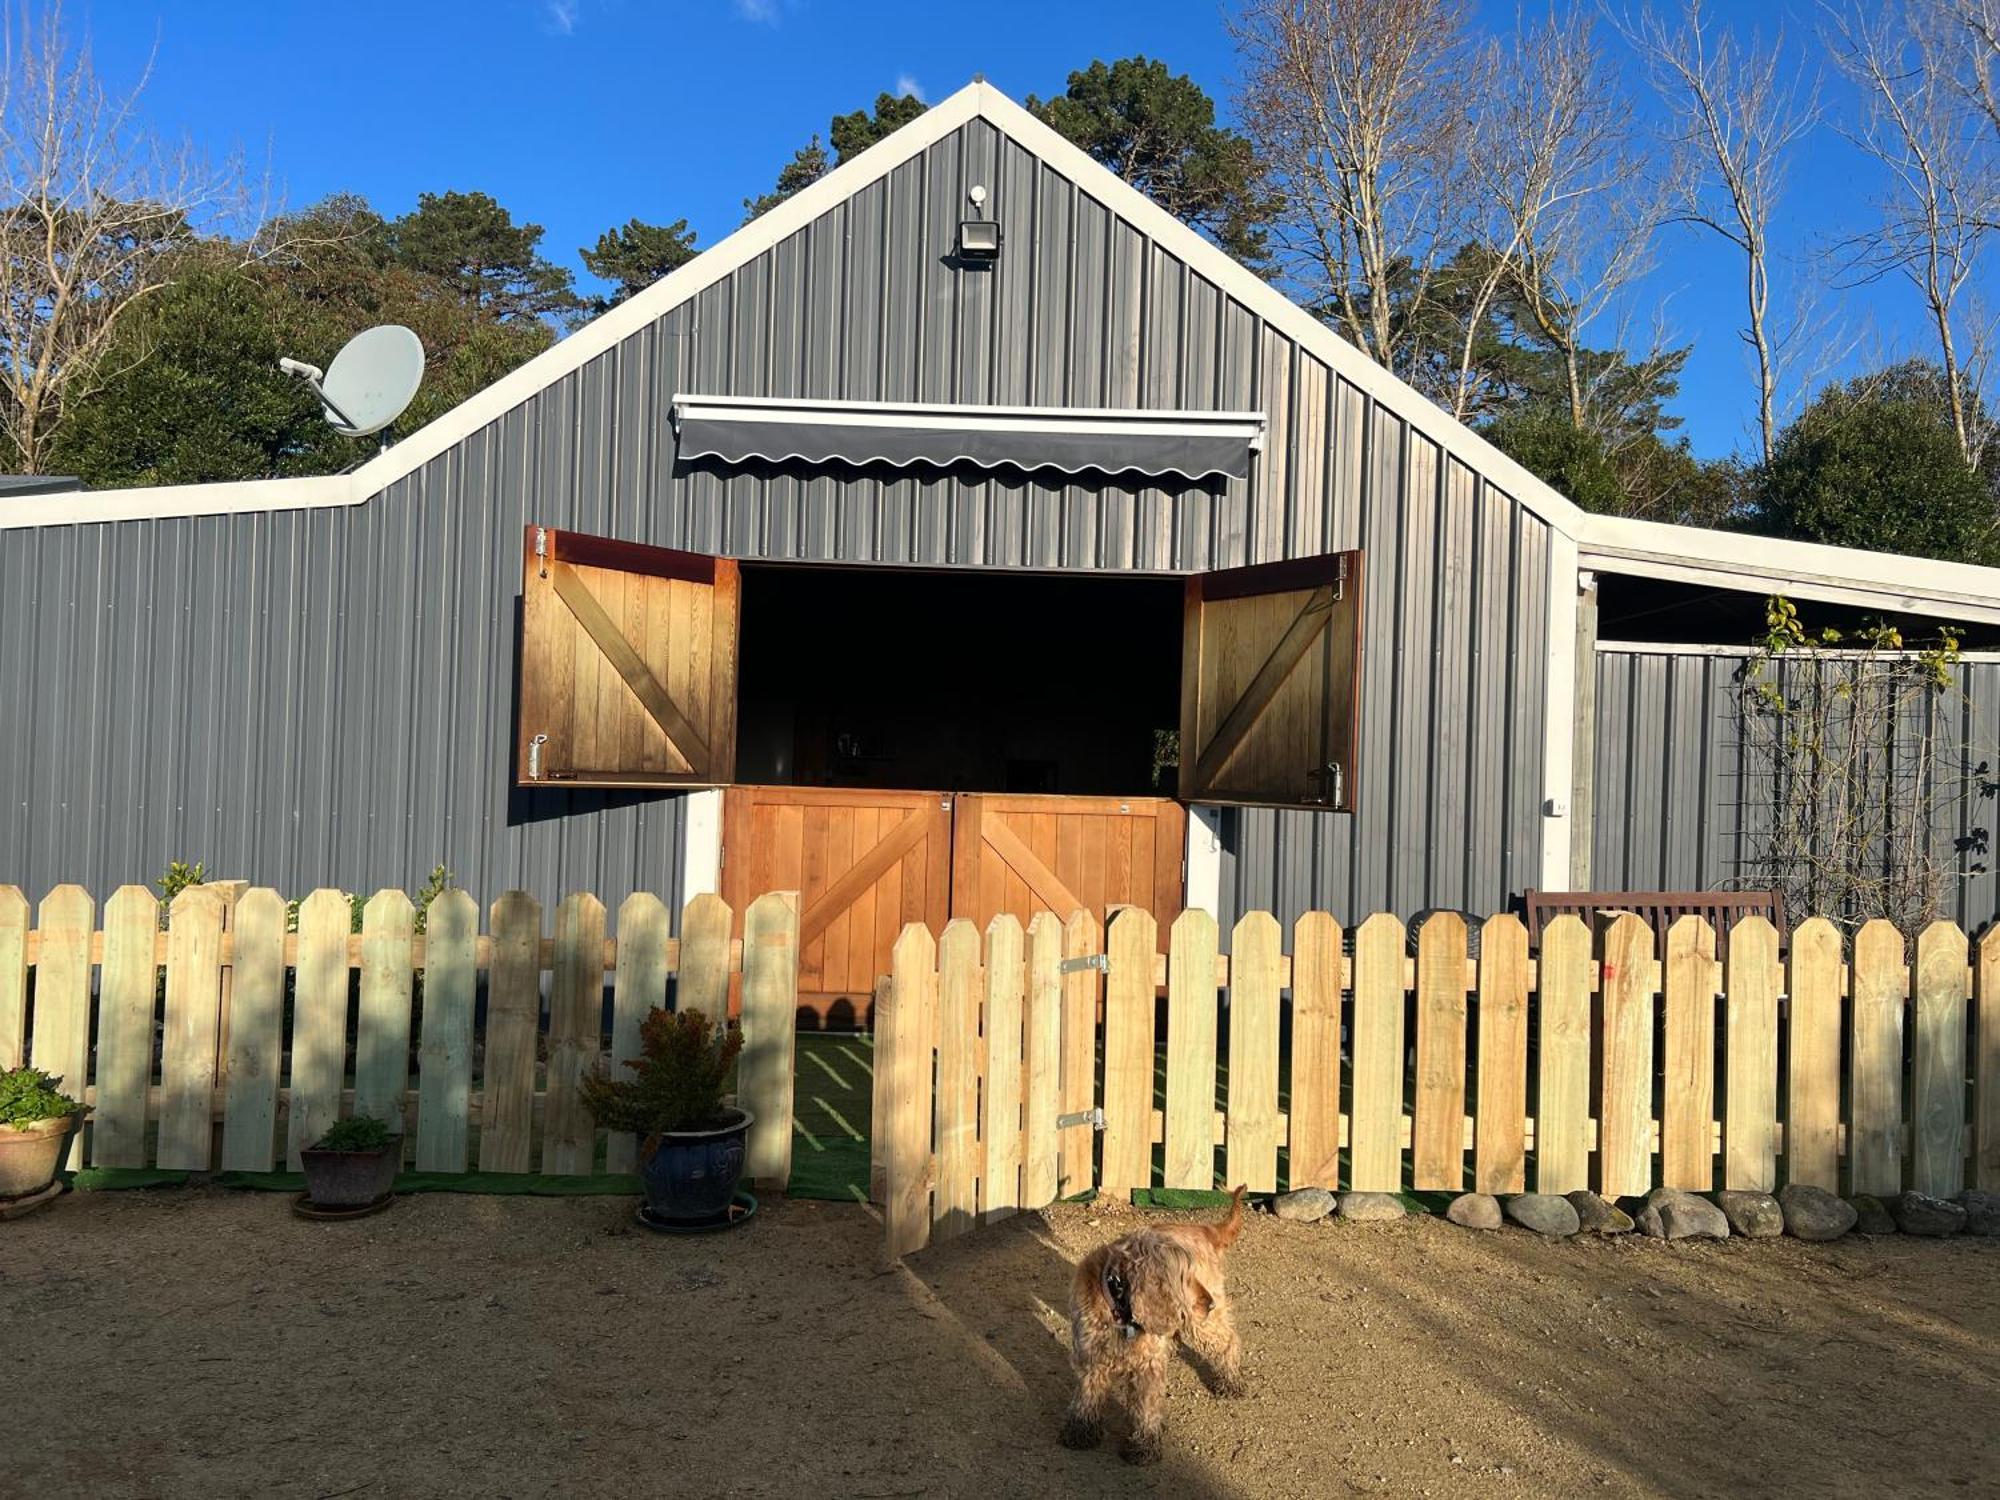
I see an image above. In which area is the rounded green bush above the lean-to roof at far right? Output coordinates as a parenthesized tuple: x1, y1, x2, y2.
(1758, 380, 2000, 564)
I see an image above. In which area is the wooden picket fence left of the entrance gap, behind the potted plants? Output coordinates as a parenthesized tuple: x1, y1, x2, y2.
(0, 882, 798, 1184)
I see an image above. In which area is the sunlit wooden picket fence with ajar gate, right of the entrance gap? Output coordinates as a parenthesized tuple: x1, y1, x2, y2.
(876, 910, 2000, 1258)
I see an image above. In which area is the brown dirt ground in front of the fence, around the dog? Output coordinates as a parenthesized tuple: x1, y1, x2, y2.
(0, 1190, 2000, 1500)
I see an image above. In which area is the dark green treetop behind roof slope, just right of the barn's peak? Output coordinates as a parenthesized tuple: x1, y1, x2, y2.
(1028, 56, 1282, 268)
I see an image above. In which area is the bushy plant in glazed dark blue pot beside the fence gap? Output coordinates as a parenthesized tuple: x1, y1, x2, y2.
(582, 1006, 752, 1226)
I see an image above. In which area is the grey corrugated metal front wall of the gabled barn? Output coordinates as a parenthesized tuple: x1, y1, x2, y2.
(0, 122, 1548, 920)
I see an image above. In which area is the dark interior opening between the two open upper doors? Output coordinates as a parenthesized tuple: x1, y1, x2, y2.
(736, 562, 1182, 796)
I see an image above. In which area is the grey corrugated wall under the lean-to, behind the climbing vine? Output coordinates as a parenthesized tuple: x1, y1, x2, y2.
(1590, 650, 2000, 930)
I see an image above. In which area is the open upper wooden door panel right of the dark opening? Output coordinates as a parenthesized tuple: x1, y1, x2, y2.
(1180, 552, 1362, 812)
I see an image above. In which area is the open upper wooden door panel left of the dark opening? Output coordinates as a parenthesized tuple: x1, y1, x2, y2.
(514, 526, 740, 786)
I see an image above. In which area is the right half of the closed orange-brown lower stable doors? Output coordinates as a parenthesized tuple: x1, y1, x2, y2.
(952, 792, 1188, 942)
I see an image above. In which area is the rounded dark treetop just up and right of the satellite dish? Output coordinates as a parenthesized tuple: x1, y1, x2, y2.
(388, 192, 578, 322)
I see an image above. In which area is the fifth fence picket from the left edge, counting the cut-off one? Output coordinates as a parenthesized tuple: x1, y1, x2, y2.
(221, 886, 284, 1172)
